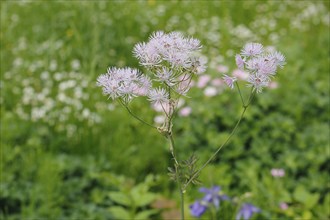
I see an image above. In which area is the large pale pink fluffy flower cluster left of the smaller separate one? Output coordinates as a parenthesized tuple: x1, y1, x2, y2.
(97, 31, 206, 105)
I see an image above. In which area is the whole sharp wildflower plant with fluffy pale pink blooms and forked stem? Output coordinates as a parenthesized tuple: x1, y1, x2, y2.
(97, 31, 285, 219)
